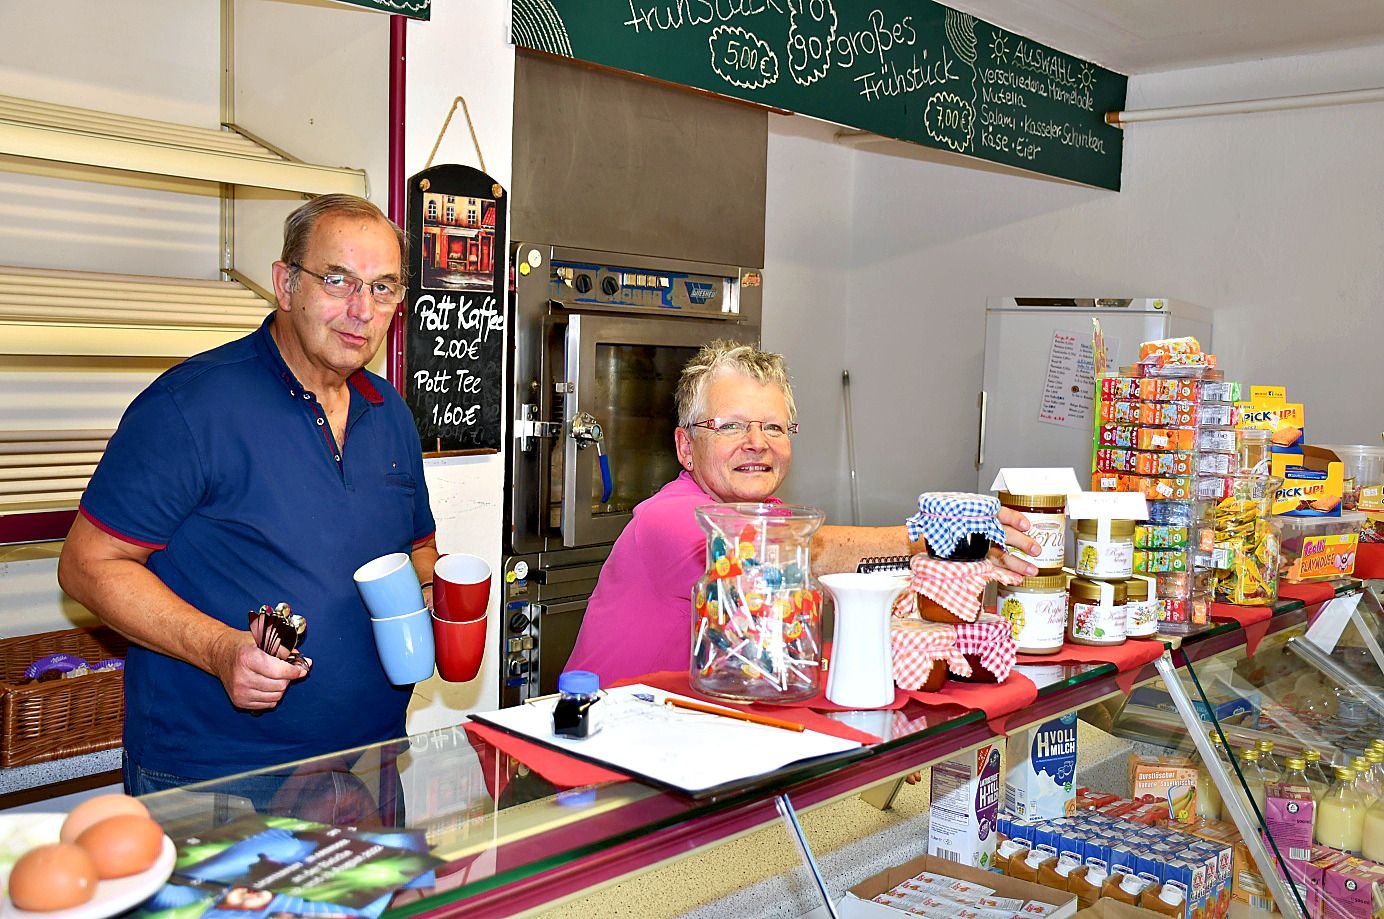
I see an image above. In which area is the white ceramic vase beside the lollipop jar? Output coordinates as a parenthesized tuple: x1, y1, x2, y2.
(818, 572, 908, 709)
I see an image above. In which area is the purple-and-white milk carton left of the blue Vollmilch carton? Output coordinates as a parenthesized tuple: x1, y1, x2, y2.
(927, 743, 999, 869)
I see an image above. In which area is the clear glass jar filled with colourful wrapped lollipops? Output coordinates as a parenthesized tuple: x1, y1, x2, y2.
(689, 502, 825, 702)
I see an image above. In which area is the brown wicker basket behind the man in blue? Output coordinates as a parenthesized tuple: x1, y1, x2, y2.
(0, 628, 129, 768)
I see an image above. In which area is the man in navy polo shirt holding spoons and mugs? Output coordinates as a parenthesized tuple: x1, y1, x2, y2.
(58, 195, 437, 807)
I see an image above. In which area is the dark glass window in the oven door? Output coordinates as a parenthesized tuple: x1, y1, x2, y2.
(583, 343, 696, 516)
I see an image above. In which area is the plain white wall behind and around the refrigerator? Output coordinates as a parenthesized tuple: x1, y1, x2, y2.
(765, 39, 1384, 523)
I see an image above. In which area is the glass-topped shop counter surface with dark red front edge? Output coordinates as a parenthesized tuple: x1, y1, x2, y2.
(134, 581, 1359, 919)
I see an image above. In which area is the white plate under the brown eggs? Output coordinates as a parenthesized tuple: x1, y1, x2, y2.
(0, 814, 177, 919)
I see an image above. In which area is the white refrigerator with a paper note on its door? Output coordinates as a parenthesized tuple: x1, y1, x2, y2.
(976, 298, 1212, 494)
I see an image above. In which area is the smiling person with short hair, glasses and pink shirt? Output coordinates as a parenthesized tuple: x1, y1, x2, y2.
(567, 340, 1039, 684)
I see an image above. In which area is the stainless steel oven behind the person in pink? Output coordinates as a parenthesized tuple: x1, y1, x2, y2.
(500, 242, 761, 706)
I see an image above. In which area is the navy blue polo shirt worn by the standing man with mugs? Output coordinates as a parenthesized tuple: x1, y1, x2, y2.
(82, 314, 435, 778)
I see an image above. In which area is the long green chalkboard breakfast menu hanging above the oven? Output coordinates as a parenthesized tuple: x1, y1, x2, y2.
(512, 0, 1127, 190)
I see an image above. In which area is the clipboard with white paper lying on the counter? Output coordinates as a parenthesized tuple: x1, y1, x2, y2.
(471, 684, 861, 797)
